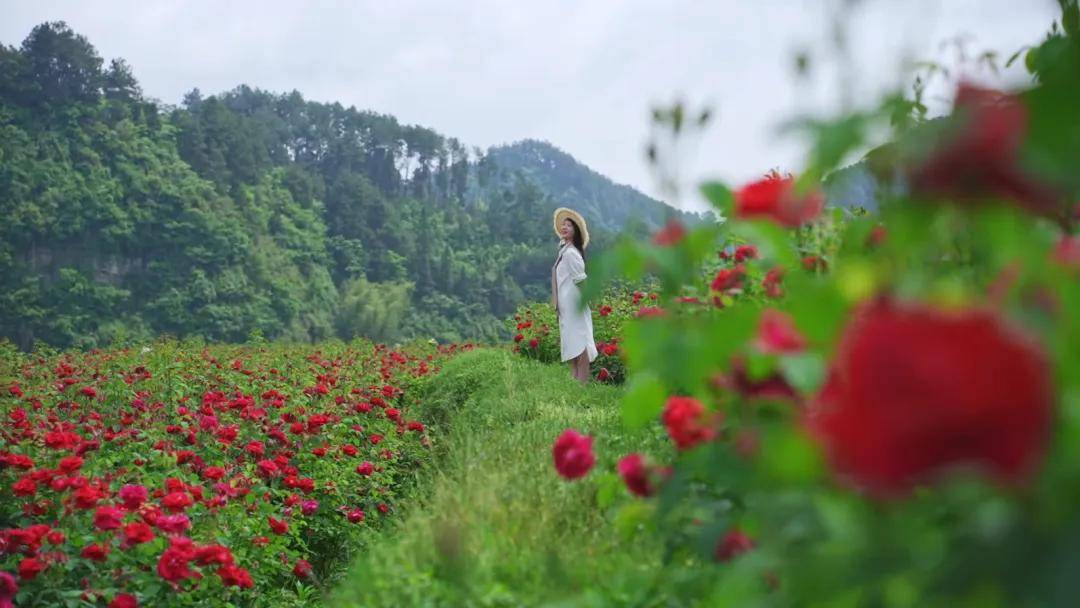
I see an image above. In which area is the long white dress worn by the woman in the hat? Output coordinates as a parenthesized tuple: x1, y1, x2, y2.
(552, 244, 597, 362)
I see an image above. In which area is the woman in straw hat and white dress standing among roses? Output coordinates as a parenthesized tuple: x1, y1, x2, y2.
(551, 207, 596, 384)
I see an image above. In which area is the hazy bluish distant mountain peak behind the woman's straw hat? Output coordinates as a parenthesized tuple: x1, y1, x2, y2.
(488, 139, 701, 232)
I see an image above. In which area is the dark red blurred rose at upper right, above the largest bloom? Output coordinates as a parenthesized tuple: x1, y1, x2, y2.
(912, 82, 1061, 212)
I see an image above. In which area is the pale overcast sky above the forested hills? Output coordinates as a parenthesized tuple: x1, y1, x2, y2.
(0, 0, 1057, 213)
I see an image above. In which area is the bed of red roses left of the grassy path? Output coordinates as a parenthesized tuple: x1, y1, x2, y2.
(0, 341, 468, 606)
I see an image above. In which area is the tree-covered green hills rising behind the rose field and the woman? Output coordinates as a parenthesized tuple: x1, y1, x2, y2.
(0, 23, 695, 348)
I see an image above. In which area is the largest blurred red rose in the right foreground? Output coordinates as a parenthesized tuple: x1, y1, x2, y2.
(808, 299, 1054, 496)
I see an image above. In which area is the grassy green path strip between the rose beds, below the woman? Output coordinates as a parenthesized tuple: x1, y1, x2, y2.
(329, 349, 670, 606)
